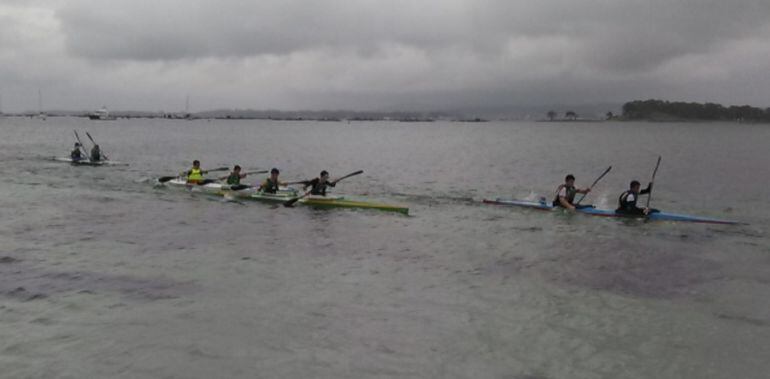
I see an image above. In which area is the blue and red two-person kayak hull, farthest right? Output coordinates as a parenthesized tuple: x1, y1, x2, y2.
(483, 198, 744, 225)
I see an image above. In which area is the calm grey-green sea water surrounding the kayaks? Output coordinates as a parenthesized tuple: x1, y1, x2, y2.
(0, 118, 770, 379)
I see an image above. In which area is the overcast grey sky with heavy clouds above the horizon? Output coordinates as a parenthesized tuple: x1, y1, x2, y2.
(0, 0, 770, 112)
